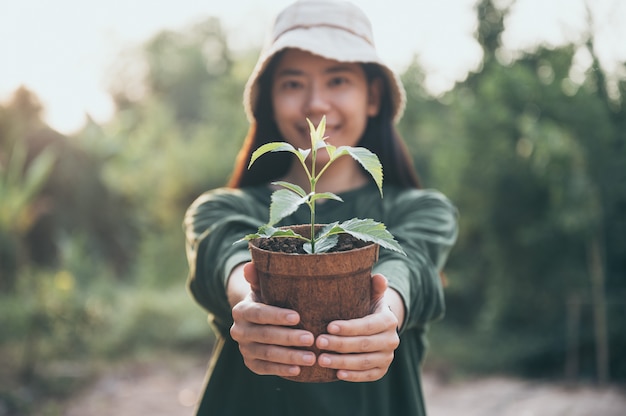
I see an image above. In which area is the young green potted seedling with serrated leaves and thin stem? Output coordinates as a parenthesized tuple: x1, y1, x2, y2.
(240, 117, 404, 254)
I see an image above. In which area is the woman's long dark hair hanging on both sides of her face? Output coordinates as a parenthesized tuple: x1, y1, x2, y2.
(228, 52, 421, 188)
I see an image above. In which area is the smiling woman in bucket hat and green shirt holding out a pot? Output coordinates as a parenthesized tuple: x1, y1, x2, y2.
(185, 0, 457, 416)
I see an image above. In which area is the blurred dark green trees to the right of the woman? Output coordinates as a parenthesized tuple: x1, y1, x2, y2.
(420, 2, 626, 379)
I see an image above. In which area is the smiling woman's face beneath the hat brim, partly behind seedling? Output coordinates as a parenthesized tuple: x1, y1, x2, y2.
(272, 49, 381, 158)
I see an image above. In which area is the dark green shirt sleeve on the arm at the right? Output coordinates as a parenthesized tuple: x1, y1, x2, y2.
(374, 190, 458, 331)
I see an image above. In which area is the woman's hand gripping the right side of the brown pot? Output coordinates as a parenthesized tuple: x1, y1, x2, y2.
(315, 274, 404, 382)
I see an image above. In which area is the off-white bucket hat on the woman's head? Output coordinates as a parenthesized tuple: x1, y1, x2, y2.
(244, 0, 406, 121)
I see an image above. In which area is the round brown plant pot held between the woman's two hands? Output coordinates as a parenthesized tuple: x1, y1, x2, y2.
(249, 225, 378, 383)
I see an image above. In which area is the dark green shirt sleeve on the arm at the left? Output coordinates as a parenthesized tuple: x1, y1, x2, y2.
(184, 189, 268, 329)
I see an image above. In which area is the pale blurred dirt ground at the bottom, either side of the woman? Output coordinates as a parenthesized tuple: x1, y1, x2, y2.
(64, 358, 626, 416)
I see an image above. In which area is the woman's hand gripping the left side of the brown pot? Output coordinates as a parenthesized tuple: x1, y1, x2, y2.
(228, 263, 316, 377)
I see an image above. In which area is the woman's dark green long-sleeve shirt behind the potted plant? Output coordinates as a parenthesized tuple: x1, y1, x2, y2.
(185, 185, 458, 416)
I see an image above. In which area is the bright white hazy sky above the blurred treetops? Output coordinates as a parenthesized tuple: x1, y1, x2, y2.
(0, 0, 626, 133)
